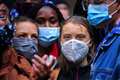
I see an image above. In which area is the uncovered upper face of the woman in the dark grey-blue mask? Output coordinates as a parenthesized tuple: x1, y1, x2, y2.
(15, 22, 38, 41)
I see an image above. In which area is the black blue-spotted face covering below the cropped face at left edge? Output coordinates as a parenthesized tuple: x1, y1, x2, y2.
(0, 24, 14, 46)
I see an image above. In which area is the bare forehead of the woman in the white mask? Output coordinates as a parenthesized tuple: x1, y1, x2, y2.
(62, 23, 87, 34)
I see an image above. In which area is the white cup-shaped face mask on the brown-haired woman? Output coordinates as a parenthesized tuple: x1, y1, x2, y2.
(61, 39, 89, 63)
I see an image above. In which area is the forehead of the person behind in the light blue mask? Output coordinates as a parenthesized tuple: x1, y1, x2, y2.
(37, 6, 57, 16)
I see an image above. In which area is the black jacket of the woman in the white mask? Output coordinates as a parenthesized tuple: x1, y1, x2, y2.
(57, 66, 90, 80)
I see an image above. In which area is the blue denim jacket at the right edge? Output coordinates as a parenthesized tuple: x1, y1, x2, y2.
(90, 25, 120, 80)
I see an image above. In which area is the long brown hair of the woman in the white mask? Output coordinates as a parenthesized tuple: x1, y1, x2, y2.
(58, 16, 95, 70)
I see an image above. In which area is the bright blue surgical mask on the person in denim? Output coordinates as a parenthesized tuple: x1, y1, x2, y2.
(87, 4, 111, 26)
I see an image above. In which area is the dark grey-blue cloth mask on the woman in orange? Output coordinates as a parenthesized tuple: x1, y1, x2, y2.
(12, 37, 38, 60)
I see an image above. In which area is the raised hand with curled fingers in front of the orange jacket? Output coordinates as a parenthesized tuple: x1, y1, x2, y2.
(32, 55, 53, 77)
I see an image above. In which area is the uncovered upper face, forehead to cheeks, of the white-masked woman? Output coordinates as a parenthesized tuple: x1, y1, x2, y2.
(61, 23, 91, 43)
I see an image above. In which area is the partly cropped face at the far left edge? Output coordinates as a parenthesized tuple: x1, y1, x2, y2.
(0, 4, 9, 26)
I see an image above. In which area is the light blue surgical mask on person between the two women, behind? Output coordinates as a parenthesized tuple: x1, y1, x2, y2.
(39, 27, 60, 47)
